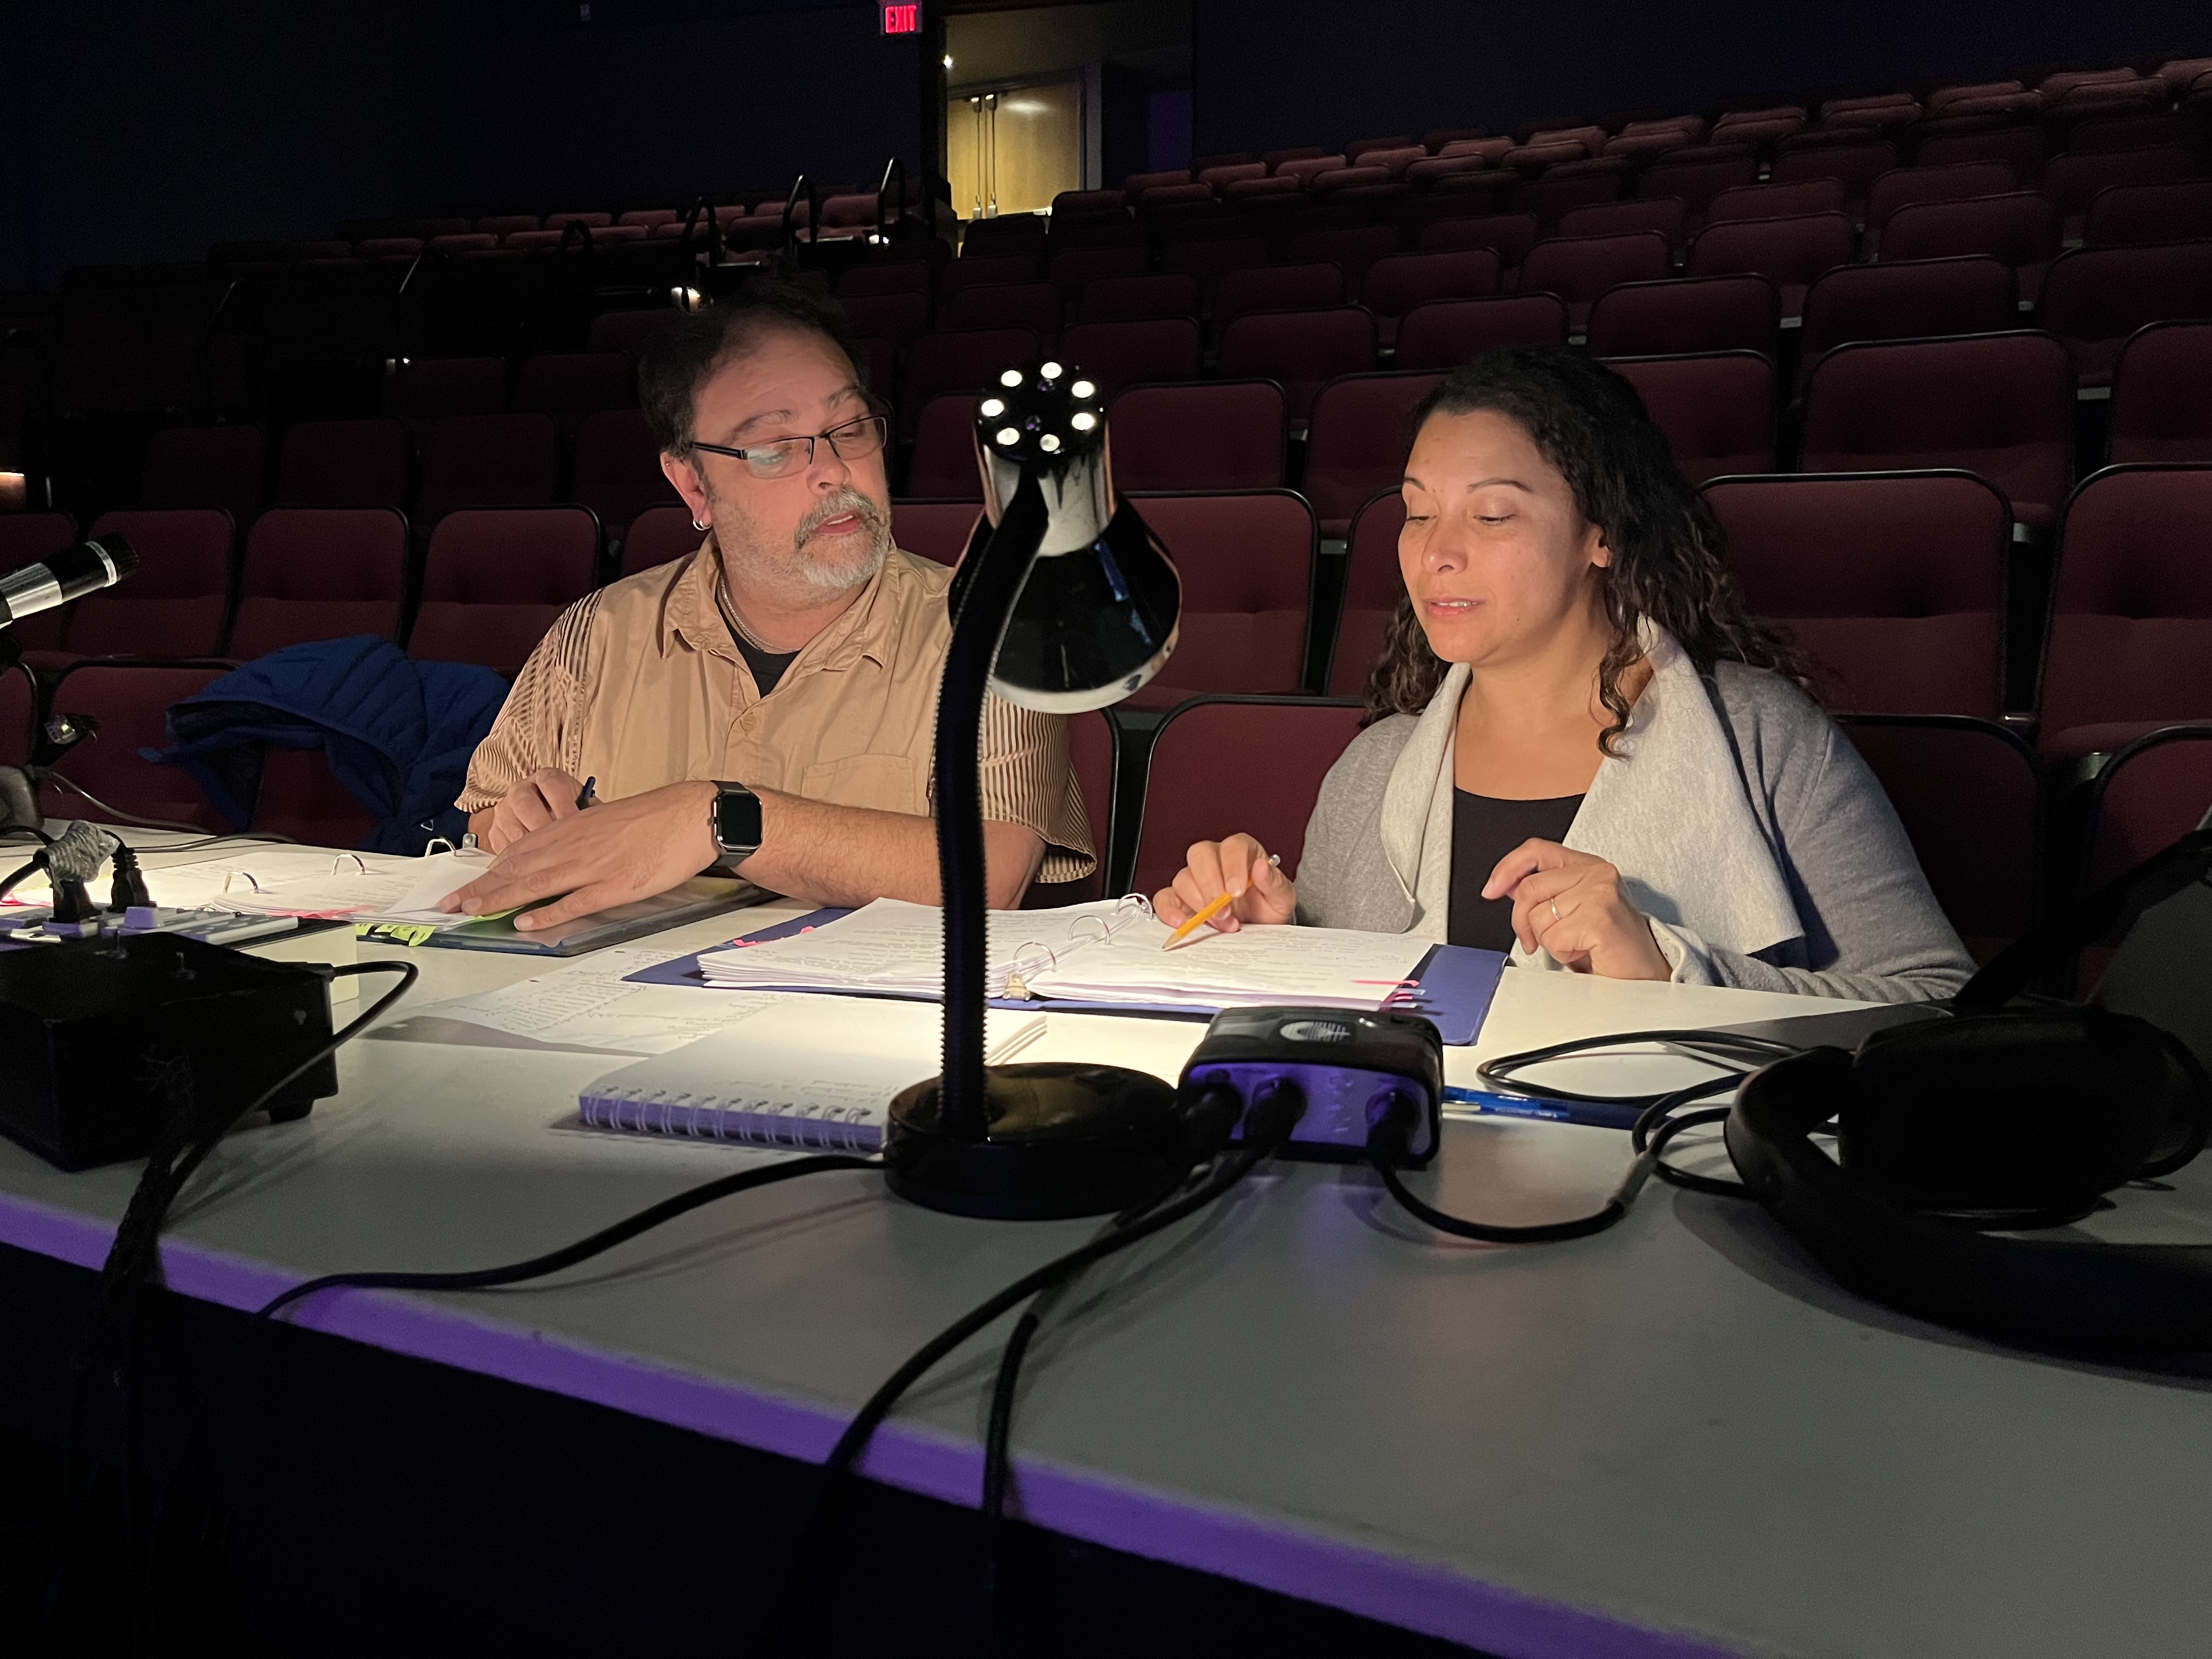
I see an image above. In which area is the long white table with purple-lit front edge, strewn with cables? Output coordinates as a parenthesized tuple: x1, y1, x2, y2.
(0, 876, 2212, 1659)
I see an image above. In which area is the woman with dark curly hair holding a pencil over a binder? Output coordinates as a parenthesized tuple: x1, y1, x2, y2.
(1155, 347, 1973, 1002)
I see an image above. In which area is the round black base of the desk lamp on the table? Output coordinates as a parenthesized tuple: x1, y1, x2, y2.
(883, 1062, 1183, 1221)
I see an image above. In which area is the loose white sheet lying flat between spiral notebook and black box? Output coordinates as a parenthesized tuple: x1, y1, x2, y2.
(374, 947, 787, 1055)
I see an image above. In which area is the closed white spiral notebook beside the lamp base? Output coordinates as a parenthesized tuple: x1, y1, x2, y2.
(577, 997, 1044, 1153)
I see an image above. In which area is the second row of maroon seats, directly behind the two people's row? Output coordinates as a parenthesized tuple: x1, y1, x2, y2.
(0, 455, 2212, 765)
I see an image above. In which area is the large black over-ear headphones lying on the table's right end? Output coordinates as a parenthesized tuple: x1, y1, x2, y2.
(1725, 830, 2212, 1352)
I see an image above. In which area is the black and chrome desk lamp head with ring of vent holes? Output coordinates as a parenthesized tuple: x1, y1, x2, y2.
(951, 360, 1183, 714)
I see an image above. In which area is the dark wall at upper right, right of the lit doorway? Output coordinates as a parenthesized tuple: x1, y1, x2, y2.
(1192, 0, 2212, 153)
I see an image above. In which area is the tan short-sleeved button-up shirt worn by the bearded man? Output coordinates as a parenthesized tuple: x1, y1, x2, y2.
(458, 535, 1093, 883)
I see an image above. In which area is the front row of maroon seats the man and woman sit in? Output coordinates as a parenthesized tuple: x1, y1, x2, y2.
(0, 664, 2212, 986)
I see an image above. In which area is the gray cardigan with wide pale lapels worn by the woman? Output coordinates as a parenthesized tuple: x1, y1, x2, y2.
(1299, 633, 1973, 1002)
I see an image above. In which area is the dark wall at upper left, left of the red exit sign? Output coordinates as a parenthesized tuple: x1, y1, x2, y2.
(0, 0, 920, 287)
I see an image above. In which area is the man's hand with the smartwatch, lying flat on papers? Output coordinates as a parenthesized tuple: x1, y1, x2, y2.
(440, 770, 719, 931)
